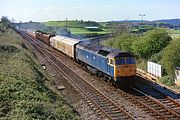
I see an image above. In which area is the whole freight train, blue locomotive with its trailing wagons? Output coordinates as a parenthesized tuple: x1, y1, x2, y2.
(27, 30, 136, 84)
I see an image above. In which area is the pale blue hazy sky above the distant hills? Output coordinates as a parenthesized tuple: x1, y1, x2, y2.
(0, 0, 180, 22)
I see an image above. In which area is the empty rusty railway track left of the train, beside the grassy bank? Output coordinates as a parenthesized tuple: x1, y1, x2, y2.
(19, 30, 135, 120)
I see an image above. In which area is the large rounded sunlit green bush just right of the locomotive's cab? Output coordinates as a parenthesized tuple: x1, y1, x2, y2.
(132, 29, 172, 59)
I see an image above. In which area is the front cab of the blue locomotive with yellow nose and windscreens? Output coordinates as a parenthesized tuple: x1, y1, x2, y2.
(107, 51, 136, 81)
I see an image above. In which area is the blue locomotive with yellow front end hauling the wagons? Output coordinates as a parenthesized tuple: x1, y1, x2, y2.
(76, 42, 136, 82)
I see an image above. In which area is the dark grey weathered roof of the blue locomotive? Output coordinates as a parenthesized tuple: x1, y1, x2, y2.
(78, 41, 133, 58)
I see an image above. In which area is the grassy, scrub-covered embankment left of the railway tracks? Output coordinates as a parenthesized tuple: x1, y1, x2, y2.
(0, 29, 76, 120)
